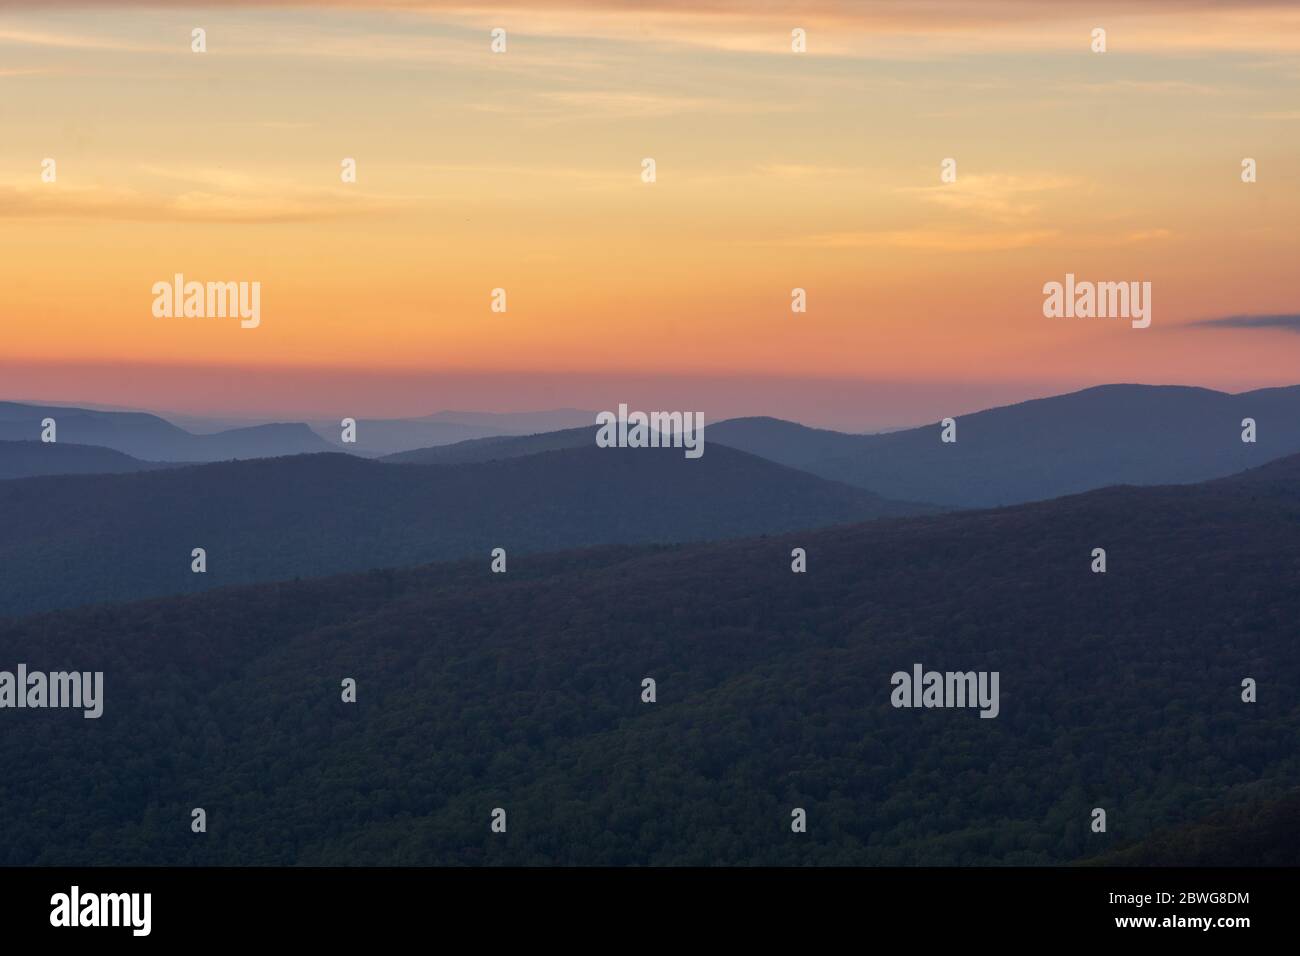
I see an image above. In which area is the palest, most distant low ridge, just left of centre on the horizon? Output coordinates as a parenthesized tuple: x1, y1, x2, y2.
(313, 408, 595, 458)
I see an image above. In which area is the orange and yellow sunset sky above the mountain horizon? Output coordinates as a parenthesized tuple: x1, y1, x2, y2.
(0, 0, 1300, 429)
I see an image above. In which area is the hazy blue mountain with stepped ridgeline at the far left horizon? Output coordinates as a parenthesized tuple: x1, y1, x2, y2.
(0, 402, 332, 462)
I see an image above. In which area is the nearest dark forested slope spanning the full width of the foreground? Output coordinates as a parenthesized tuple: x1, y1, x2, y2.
(0, 451, 1300, 865)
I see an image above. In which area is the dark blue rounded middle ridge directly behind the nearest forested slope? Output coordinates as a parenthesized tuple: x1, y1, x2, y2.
(0, 446, 932, 615)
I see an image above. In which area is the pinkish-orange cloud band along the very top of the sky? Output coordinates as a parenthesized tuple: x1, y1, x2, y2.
(0, 0, 1300, 59)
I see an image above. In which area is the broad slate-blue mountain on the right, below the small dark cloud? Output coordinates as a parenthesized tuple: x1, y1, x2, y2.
(706, 385, 1300, 507)
